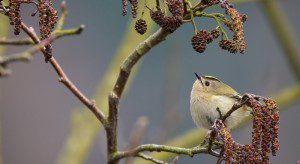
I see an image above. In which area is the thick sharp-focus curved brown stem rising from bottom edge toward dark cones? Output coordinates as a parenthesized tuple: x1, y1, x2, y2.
(106, 28, 169, 163)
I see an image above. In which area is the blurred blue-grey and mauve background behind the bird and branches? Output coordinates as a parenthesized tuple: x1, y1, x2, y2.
(0, 0, 300, 164)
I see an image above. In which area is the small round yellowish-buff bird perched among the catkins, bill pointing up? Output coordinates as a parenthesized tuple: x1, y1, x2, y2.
(190, 73, 250, 129)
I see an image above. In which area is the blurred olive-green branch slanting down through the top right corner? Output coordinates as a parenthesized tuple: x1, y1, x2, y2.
(259, 0, 300, 80)
